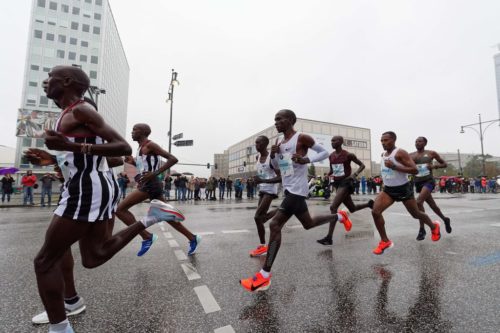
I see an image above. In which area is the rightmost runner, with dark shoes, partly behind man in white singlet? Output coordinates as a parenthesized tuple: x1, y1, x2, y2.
(410, 136, 451, 240)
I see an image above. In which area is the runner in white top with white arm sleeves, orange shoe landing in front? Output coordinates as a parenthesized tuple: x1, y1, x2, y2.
(240, 110, 350, 291)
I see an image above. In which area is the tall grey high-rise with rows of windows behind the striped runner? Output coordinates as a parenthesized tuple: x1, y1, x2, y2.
(15, 0, 129, 171)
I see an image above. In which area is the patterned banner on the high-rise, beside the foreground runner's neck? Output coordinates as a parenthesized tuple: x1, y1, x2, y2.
(16, 109, 59, 138)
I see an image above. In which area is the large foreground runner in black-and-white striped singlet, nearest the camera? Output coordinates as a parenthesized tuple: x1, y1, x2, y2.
(25, 66, 184, 332)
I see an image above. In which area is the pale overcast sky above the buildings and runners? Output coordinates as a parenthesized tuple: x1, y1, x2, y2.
(0, 0, 500, 175)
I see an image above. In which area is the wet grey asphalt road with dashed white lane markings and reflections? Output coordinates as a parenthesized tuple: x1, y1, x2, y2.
(0, 195, 500, 333)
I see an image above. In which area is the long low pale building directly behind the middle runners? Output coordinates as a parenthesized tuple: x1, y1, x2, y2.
(213, 118, 371, 179)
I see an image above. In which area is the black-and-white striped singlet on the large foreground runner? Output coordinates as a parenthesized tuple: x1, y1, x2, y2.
(54, 101, 120, 222)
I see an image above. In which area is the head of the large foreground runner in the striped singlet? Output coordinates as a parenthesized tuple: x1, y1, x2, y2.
(43, 66, 90, 99)
